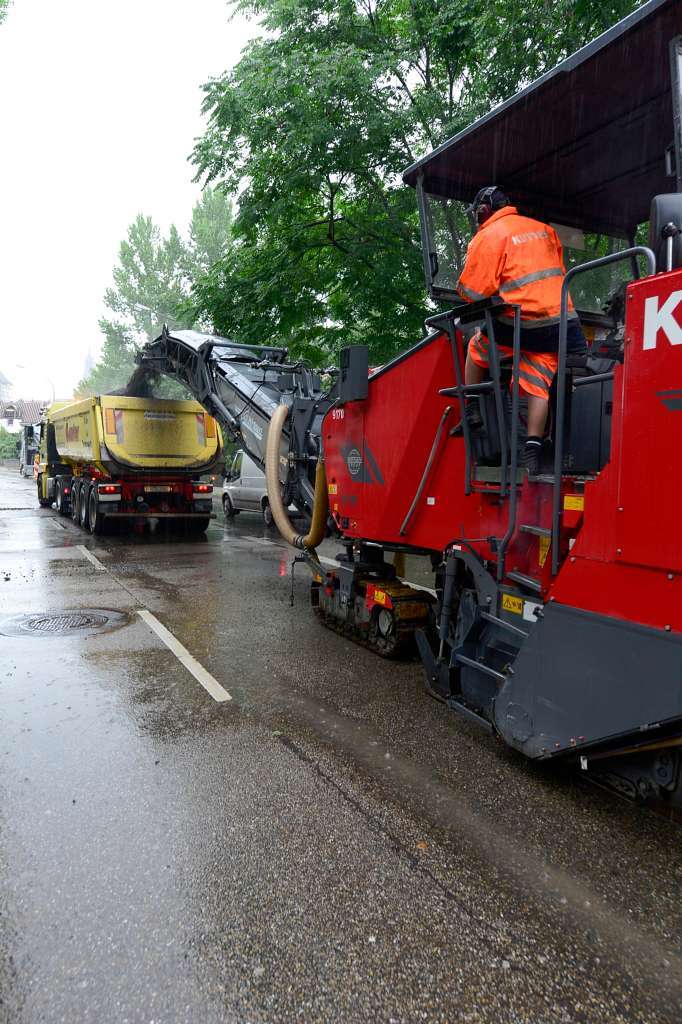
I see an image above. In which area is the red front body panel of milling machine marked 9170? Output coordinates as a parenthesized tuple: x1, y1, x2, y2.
(323, 335, 551, 583)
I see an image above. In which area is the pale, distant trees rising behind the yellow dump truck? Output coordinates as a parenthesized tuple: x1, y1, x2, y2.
(78, 188, 232, 395)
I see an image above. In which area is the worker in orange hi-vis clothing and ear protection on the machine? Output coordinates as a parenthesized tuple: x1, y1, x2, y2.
(456, 185, 586, 475)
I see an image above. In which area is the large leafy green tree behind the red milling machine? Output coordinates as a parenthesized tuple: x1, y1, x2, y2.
(193, 0, 637, 361)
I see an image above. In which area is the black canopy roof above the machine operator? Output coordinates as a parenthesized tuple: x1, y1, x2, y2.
(403, 0, 682, 234)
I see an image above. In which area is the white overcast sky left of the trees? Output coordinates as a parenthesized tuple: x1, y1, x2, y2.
(0, 0, 255, 398)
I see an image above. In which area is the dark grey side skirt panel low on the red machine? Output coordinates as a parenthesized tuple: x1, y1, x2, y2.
(494, 603, 682, 758)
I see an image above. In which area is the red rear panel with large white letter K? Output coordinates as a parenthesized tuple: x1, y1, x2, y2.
(550, 270, 682, 631)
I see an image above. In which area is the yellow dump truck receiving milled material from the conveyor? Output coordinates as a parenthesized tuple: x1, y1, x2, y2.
(37, 395, 222, 534)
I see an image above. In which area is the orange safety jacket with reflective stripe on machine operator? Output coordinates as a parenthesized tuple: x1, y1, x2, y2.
(457, 206, 576, 330)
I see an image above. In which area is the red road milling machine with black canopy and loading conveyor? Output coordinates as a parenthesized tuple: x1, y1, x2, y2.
(143, 0, 682, 806)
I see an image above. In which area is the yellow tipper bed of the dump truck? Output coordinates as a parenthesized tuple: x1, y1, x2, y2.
(47, 395, 222, 475)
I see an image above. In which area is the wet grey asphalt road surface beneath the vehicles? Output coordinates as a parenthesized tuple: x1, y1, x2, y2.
(0, 469, 682, 1024)
